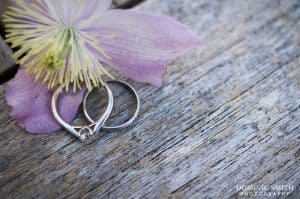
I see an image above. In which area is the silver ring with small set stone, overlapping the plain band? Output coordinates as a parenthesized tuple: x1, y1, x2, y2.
(51, 83, 114, 141)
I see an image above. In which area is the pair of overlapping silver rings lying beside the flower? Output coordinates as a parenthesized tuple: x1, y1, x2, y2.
(51, 80, 140, 141)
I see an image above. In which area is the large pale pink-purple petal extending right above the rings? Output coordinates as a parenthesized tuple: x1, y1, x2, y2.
(81, 10, 199, 87)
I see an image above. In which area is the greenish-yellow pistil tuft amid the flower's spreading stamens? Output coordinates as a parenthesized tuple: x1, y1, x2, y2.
(42, 27, 72, 70)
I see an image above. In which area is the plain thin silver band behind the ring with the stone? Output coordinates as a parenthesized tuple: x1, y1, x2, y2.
(83, 80, 141, 130)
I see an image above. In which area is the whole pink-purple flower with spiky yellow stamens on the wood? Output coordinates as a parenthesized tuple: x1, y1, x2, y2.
(4, 0, 199, 133)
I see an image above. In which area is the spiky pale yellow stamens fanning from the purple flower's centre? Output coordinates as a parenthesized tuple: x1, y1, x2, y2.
(0, 0, 116, 92)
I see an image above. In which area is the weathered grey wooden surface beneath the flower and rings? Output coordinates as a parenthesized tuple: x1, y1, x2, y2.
(0, 0, 300, 198)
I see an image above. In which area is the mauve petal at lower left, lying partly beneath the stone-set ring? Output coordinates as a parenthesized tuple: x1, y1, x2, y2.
(5, 68, 85, 133)
